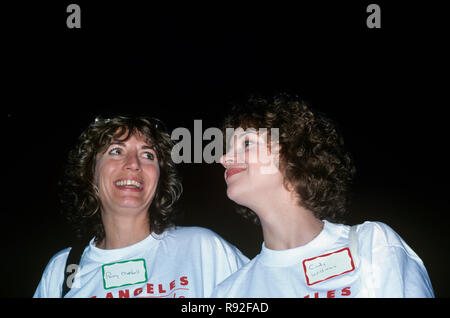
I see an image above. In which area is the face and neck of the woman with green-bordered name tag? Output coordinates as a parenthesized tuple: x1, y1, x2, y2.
(94, 134, 160, 248)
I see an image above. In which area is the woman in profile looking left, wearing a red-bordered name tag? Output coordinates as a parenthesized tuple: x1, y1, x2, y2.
(213, 95, 433, 298)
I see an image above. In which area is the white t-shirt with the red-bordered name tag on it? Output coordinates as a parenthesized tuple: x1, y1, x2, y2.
(212, 221, 434, 298)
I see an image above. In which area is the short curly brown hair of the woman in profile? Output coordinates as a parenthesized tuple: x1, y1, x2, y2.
(222, 94, 356, 224)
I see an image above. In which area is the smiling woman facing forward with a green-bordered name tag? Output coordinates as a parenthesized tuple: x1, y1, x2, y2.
(34, 117, 248, 298)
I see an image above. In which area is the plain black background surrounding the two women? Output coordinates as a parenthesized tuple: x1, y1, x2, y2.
(0, 1, 450, 297)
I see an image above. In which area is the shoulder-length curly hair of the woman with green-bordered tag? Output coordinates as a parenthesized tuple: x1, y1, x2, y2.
(60, 116, 183, 242)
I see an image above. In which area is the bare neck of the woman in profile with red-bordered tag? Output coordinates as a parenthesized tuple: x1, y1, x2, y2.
(253, 189, 324, 250)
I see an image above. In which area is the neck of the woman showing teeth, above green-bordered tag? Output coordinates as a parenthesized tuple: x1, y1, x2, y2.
(97, 207, 150, 249)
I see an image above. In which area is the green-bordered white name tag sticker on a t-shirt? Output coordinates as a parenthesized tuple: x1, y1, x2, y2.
(102, 259, 147, 289)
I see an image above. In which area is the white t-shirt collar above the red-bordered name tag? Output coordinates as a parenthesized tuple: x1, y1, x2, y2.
(258, 220, 343, 267)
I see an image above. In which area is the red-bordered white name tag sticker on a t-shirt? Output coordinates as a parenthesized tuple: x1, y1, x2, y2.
(303, 248, 355, 286)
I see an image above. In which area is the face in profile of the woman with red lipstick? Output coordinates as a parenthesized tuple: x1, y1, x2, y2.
(221, 128, 283, 208)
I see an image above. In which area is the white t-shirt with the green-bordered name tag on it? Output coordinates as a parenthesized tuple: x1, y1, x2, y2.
(34, 227, 248, 298)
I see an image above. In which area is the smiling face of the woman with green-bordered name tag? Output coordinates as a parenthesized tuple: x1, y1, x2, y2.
(95, 134, 160, 216)
